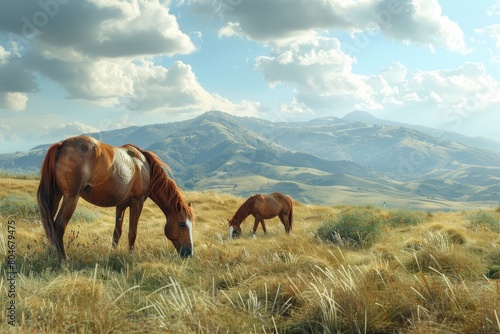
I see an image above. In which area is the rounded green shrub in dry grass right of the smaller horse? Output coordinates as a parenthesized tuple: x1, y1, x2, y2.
(316, 208, 385, 246)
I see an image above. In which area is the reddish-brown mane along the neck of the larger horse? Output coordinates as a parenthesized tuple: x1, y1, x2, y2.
(127, 144, 194, 221)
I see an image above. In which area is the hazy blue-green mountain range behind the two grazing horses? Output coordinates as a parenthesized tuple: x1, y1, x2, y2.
(0, 111, 500, 208)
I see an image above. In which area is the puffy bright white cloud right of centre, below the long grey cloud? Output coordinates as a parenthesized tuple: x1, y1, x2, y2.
(255, 37, 379, 113)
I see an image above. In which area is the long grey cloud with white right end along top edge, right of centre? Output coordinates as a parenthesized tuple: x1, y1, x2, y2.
(192, 0, 467, 52)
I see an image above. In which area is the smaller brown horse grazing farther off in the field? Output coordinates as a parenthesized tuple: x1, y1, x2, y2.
(228, 193, 293, 238)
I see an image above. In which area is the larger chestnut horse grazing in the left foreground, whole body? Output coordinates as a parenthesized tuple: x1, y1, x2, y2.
(37, 136, 194, 260)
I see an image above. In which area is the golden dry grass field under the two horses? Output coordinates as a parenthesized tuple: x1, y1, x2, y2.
(0, 178, 500, 334)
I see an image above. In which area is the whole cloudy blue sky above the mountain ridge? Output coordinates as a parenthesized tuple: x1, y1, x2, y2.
(0, 0, 500, 153)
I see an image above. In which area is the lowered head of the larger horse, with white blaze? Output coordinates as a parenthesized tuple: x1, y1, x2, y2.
(165, 201, 193, 257)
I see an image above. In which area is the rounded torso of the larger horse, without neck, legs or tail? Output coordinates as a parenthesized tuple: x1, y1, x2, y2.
(56, 136, 150, 206)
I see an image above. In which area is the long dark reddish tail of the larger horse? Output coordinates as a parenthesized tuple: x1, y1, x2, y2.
(37, 143, 62, 244)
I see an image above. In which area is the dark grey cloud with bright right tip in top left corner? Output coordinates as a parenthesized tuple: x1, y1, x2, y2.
(0, 0, 195, 57)
